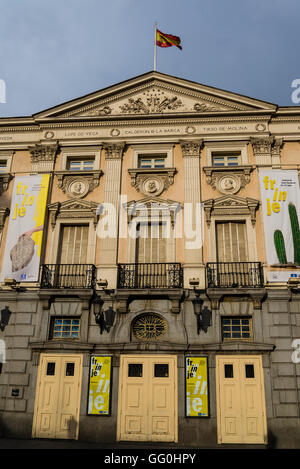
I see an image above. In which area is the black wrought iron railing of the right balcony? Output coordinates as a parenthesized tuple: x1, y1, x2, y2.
(206, 262, 264, 288)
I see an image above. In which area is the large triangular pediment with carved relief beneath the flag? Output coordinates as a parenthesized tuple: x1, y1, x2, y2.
(34, 72, 277, 120)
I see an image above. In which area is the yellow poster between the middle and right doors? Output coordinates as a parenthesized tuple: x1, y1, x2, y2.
(185, 357, 209, 417)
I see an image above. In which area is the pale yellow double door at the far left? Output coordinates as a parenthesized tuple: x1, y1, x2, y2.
(32, 354, 82, 439)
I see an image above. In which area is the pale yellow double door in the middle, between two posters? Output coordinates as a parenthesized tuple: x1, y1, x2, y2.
(117, 355, 178, 442)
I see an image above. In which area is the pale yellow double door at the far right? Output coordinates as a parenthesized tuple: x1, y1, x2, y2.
(216, 355, 267, 444)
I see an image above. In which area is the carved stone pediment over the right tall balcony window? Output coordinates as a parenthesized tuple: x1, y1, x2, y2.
(203, 195, 259, 227)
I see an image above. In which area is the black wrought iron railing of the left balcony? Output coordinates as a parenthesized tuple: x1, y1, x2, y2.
(41, 264, 96, 288)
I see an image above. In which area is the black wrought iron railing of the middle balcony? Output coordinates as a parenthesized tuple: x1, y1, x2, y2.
(118, 263, 183, 289)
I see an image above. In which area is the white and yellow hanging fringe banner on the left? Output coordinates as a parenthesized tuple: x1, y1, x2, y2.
(1, 174, 50, 282)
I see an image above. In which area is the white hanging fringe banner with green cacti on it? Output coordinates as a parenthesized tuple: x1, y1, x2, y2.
(259, 170, 300, 282)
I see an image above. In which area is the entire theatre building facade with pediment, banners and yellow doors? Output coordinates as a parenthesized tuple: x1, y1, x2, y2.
(0, 72, 300, 448)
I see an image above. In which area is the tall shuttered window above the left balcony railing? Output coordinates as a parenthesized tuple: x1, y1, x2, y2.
(58, 225, 89, 264)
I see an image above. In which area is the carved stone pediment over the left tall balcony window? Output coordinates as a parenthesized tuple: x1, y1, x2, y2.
(48, 198, 99, 229)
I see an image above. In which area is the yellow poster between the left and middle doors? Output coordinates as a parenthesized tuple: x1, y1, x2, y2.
(88, 356, 111, 415)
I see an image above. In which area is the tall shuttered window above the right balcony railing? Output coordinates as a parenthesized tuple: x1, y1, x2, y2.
(216, 222, 248, 262)
